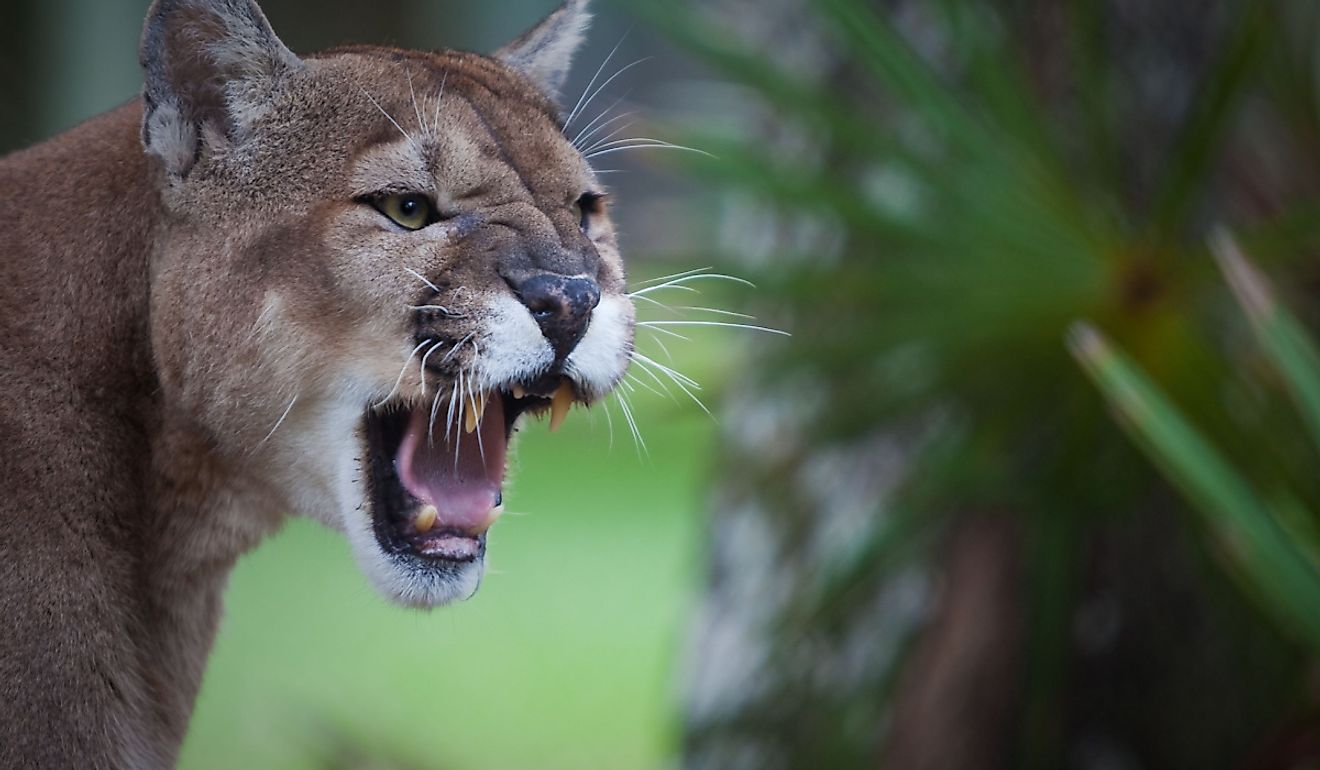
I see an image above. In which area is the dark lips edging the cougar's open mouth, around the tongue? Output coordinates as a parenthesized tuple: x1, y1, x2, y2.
(362, 374, 575, 568)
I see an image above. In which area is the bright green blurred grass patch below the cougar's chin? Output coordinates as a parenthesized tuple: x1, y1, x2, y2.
(181, 335, 718, 770)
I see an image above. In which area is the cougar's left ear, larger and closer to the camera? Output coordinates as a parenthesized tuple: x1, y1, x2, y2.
(139, 0, 302, 176)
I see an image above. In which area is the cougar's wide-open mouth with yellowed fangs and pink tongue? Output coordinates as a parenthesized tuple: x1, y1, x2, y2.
(363, 375, 581, 565)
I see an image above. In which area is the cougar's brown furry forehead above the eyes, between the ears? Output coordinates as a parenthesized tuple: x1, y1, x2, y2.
(182, 46, 590, 214)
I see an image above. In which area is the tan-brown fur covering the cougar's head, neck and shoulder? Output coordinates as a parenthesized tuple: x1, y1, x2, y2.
(0, 0, 631, 767)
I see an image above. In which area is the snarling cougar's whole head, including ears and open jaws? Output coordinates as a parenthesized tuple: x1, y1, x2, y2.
(144, 3, 634, 606)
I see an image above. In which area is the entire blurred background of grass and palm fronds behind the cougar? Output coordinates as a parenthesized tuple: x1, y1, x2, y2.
(0, 0, 1320, 770)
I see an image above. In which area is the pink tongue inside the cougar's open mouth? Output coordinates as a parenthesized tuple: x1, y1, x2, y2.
(395, 396, 508, 535)
